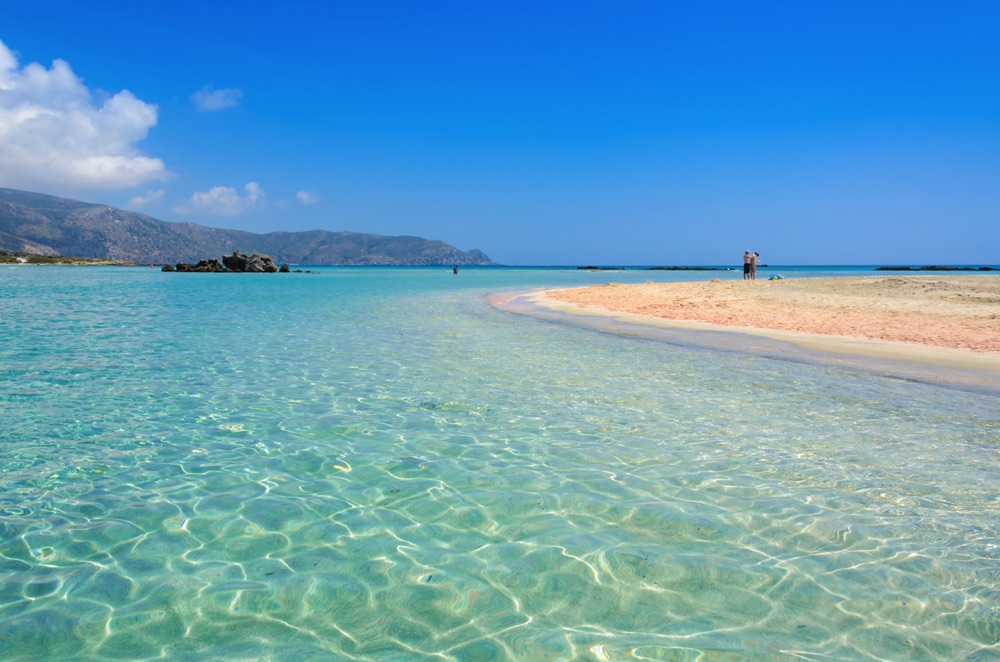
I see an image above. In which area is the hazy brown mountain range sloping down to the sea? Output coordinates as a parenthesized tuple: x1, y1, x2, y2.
(0, 188, 493, 266)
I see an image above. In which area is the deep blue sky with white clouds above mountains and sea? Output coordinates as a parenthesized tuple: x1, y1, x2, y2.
(0, 0, 1000, 265)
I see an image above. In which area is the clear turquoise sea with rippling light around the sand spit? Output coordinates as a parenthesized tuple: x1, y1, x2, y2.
(0, 267, 1000, 661)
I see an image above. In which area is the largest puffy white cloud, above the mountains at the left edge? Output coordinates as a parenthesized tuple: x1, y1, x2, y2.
(0, 41, 168, 190)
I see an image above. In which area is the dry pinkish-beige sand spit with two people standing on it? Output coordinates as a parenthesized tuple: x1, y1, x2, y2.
(540, 275, 1000, 365)
